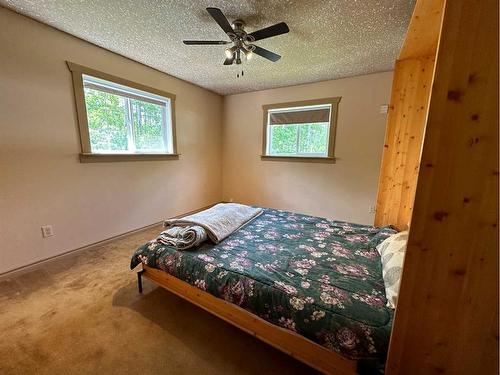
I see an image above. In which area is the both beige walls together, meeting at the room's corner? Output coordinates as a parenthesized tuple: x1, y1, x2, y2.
(0, 8, 392, 273)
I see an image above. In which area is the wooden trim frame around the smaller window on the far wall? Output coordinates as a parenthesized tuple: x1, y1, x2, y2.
(261, 96, 341, 163)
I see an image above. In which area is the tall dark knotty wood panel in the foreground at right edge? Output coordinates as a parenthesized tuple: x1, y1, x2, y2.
(387, 0, 499, 374)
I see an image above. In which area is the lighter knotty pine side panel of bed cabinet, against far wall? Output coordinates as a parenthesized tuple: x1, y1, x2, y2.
(375, 57, 434, 229)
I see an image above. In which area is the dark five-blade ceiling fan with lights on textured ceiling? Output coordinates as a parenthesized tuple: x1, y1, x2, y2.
(183, 8, 290, 65)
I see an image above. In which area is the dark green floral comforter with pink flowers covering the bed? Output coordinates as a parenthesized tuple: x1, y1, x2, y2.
(131, 209, 395, 359)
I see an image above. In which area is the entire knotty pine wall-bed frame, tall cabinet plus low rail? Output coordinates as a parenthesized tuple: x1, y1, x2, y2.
(138, 0, 499, 375)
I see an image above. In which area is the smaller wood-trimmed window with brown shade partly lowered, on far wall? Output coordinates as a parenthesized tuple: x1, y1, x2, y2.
(262, 98, 340, 161)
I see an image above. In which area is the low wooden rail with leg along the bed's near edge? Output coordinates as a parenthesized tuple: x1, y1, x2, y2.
(137, 265, 357, 375)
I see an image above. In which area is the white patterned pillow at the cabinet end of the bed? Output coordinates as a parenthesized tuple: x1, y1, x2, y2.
(377, 231, 408, 309)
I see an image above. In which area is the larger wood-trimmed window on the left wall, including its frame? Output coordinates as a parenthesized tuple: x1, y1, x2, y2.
(68, 63, 177, 162)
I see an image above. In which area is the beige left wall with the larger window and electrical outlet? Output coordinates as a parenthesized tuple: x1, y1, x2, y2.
(0, 8, 222, 273)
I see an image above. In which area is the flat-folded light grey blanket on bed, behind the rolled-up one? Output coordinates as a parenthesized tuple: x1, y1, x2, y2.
(163, 203, 263, 243)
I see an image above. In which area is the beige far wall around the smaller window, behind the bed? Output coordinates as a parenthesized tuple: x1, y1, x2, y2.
(222, 72, 392, 224)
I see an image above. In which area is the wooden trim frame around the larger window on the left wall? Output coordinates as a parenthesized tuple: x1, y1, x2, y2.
(66, 61, 179, 163)
